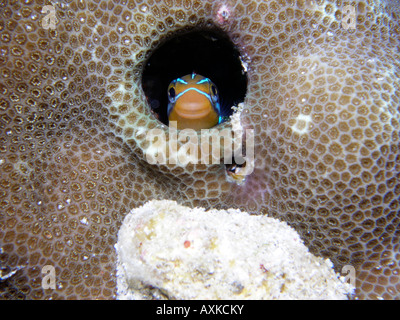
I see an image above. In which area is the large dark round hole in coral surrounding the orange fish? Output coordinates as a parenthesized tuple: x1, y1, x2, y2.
(142, 28, 247, 124)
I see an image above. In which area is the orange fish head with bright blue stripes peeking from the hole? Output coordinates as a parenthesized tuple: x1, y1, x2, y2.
(168, 72, 222, 130)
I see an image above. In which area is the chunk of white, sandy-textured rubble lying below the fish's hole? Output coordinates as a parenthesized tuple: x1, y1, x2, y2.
(116, 200, 353, 299)
